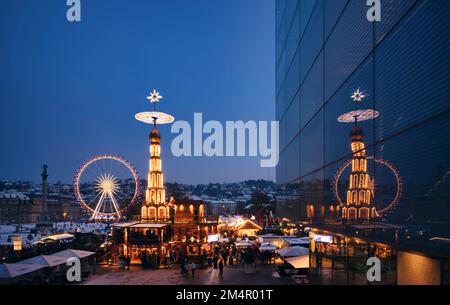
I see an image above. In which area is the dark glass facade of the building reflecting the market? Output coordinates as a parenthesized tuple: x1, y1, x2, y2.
(276, 0, 450, 282)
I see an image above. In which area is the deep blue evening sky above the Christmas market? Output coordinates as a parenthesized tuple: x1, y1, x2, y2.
(0, 0, 275, 183)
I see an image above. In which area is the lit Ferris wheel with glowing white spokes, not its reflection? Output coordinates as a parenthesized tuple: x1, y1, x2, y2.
(73, 155, 141, 220)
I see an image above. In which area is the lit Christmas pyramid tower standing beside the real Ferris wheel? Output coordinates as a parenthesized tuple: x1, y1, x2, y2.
(136, 90, 174, 221)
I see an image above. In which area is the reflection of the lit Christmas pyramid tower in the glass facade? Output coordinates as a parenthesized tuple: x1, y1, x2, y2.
(339, 89, 378, 222)
